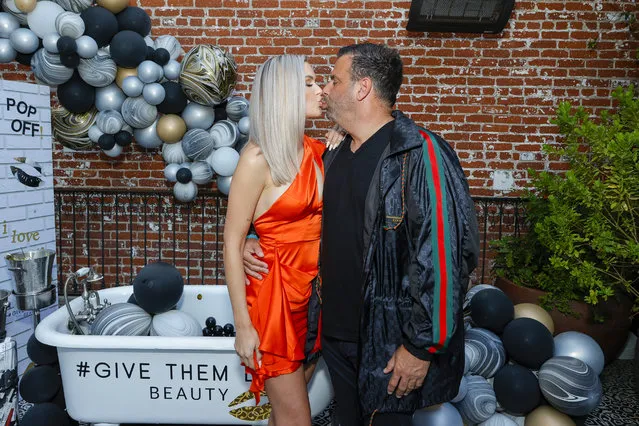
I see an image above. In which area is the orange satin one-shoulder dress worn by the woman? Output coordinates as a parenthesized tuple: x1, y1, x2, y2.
(246, 136, 325, 403)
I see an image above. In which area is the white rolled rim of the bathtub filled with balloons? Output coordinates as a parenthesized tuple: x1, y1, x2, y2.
(35, 285, 235, 352)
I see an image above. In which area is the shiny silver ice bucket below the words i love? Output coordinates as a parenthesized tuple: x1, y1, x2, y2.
(5, 249, 55, 295)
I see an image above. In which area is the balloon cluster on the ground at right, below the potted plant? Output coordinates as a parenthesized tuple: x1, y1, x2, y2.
(413, 284, 604, 426)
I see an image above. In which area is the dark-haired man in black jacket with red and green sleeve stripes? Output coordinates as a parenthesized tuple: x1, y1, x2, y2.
(244, 43, 479, 426)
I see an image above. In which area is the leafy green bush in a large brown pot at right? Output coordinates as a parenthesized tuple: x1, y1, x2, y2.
(493, 86, 639, 361)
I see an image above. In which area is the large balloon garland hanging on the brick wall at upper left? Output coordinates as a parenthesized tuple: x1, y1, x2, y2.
(0, 0, 249, 202)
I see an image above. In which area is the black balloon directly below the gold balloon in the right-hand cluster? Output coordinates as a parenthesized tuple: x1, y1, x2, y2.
(502, 318, 555, 370)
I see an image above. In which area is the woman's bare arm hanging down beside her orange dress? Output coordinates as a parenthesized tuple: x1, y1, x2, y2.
(224, 145, 269, 368)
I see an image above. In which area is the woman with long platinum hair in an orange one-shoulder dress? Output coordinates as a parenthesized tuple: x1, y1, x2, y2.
(224, 55, 325, 426)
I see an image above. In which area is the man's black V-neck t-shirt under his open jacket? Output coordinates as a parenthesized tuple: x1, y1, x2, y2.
(321, 121, 393, 342)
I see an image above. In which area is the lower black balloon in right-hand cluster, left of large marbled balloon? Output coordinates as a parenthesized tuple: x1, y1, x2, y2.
(493, 365, 541, 416)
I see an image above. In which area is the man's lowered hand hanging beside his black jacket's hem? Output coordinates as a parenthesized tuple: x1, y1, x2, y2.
(384, 346, 430, 398)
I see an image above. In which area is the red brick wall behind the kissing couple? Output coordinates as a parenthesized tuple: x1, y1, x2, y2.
(0, 0, 639, 195)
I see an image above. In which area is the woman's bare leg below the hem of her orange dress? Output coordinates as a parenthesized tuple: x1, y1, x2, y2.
(264, 368, 311, 426)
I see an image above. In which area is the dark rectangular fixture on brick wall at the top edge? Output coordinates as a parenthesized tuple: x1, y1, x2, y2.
(406, 0, 515, 33)
